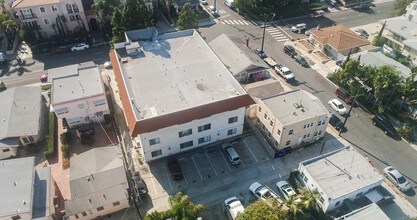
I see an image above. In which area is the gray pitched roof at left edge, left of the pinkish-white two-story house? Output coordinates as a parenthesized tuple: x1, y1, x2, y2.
(0, 86, 43, 140)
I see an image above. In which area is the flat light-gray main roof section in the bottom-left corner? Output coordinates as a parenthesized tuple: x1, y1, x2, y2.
(0, 157, 35, 218)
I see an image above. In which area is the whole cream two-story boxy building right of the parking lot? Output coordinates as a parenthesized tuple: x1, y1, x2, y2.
(252, 89, 330, 151)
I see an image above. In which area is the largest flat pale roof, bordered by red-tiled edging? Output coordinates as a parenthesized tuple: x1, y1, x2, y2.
(116, 30, 246, 120)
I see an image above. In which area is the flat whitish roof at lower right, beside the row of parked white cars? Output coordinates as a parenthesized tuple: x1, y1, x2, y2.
(300, 147, 383, 199)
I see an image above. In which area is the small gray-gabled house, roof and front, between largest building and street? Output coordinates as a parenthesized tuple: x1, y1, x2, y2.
(209, 34, 268, 83)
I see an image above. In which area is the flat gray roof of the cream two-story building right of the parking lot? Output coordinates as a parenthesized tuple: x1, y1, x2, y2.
(262, 89, 330, 125)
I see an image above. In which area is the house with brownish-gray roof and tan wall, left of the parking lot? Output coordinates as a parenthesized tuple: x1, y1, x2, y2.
(64, 146, 130, 219)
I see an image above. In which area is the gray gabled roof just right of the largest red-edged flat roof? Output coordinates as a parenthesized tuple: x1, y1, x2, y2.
(209, 34, 268, 76)
